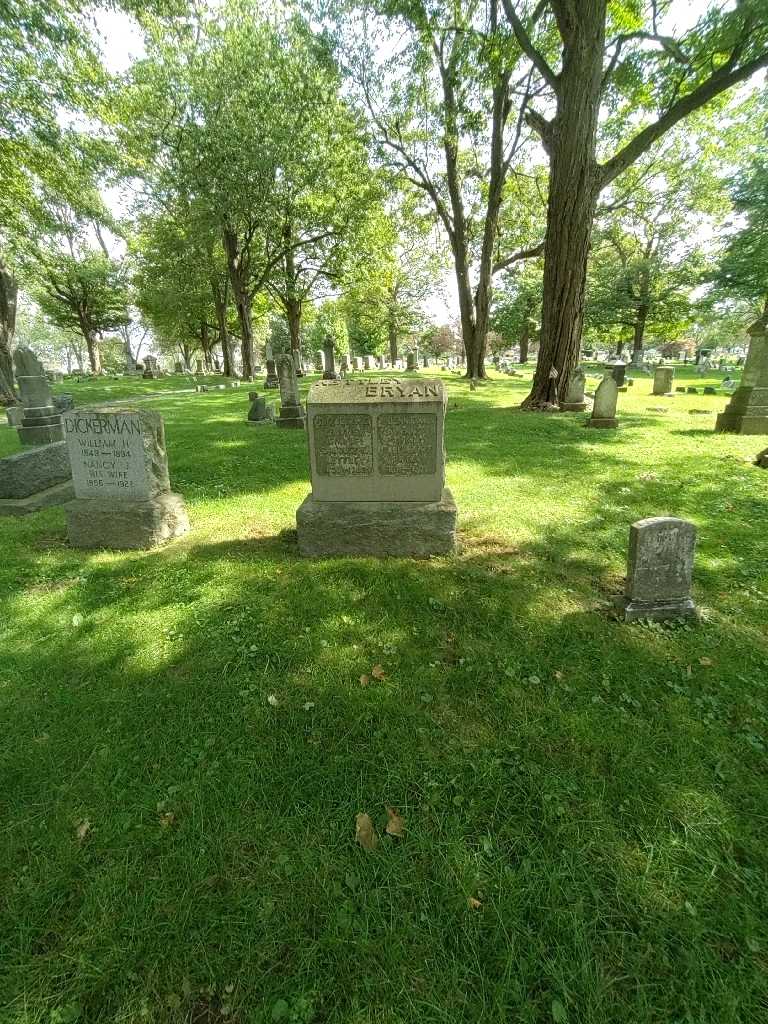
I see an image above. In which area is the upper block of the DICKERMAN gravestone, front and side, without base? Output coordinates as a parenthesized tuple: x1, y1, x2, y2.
(62, 409, 169, 501)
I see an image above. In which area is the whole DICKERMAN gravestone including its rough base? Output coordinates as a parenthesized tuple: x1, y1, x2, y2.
(61, 408, 189, 550)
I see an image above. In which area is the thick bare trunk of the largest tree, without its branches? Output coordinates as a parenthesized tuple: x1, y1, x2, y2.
(523, 0, 606, 409)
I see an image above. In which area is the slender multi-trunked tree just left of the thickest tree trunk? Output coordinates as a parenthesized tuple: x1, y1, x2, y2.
(343, 0, 541, 377)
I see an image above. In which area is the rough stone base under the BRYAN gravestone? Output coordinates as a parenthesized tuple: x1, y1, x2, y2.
(296, 487, 457, 558)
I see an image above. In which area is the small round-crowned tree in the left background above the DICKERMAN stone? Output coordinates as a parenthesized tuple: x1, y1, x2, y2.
(36, 252, 129, 374)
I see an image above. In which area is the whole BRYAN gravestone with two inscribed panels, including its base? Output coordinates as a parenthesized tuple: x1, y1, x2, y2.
(296, 378, 457, 556)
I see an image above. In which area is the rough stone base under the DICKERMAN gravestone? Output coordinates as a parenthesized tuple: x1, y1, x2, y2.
(65, 490, 189, 551)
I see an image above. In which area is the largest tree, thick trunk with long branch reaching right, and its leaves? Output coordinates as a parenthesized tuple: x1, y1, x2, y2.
(503, 0, 768, 409)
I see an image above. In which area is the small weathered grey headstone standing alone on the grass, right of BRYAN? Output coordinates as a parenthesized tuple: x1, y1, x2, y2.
(616, 516, 697, 623)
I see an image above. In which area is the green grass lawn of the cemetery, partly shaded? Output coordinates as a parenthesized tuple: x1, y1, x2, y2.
(0, 371, 768, 1024)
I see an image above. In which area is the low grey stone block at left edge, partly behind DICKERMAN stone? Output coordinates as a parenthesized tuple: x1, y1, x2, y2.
(0, 441, 75, 516)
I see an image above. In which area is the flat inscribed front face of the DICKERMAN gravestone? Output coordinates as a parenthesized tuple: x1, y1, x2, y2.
(61, 412, 150, 499)
